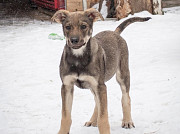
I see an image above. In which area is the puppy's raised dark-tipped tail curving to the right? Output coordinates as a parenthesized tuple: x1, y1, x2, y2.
(115, 17, 151, 34)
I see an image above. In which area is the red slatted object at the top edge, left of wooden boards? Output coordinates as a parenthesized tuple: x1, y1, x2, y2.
(32, 0, 65, 10)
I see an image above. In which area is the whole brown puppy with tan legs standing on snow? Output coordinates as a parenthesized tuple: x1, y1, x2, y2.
(52, 9, 150, 134)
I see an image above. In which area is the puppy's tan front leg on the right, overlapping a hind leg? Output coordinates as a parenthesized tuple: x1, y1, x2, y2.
(93, 84, 110, 134)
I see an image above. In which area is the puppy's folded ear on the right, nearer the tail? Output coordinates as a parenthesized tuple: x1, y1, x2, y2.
(84, 8, 104, 22)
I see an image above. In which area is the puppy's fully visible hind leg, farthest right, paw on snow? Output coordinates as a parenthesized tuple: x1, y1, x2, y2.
(116, 47, 134, 128)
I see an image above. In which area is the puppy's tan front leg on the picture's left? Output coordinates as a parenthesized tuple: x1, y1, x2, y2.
(58, 85, 74, 134)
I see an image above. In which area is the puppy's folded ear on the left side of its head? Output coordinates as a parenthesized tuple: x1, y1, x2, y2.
(51, 10, 69, 23)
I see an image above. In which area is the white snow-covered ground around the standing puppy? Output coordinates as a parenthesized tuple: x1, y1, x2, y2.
(0, 7, 180, 134)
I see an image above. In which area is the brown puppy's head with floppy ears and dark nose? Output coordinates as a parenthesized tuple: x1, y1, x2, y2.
(52, 8, 103, 49)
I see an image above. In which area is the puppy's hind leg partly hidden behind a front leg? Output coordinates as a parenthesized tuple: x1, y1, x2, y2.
(84, 93, 98, 127)
